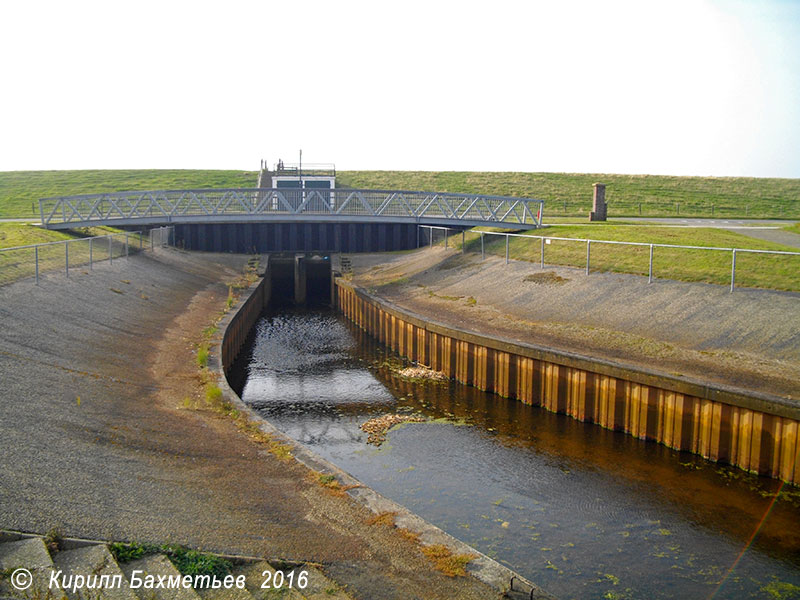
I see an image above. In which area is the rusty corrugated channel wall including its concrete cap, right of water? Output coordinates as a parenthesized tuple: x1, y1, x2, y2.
(336, 279, 800, 484)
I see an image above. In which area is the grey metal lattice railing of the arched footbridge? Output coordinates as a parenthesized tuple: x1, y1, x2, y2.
(39, 188, 544, 229)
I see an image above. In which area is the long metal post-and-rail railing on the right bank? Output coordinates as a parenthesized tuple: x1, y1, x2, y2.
(420, 225, 800, 292)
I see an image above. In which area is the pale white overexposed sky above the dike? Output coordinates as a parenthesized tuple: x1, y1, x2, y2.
(0, 0, 800, 178)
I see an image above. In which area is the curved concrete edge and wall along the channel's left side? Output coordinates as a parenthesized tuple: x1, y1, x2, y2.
(214, 277, 552, 598)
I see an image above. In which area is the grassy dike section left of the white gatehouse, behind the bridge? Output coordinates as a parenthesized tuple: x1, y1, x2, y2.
(0, 169, 258, 218)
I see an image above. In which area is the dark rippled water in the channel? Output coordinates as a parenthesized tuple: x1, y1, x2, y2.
(242, 311, 800, 598)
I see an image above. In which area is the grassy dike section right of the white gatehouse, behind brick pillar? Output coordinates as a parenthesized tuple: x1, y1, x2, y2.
(336, 171, 800, 218)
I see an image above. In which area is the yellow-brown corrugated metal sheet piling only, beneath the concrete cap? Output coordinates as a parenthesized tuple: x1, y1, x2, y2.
(337, 285, 800, 483)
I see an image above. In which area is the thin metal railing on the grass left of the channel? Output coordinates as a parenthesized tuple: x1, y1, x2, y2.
(0, 227, 174, 285)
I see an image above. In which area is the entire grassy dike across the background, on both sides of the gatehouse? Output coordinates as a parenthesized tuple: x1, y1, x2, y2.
(0, 169, 800, 218)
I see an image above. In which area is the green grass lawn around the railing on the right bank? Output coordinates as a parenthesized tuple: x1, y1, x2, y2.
(451, 224, 800, 291)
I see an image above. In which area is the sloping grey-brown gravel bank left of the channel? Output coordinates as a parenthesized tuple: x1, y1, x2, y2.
(0, 250, 497, 599)
